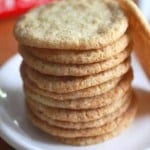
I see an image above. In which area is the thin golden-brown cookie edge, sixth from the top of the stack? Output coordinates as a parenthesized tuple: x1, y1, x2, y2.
(25, 88, 131, 110)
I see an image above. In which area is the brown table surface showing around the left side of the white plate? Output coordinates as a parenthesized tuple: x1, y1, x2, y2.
(0, 19, 17, 150)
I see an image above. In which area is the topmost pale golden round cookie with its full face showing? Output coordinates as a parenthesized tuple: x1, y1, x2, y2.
(14, 0, 128, 50)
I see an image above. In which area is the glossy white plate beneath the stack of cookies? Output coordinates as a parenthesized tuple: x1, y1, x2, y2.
(0, 55, 150, 150)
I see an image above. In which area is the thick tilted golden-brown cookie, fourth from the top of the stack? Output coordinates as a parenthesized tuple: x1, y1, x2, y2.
(21, 59, 130, 93)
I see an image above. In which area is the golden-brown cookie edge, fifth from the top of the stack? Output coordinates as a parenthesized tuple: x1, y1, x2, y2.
(22, 70, 133, 101)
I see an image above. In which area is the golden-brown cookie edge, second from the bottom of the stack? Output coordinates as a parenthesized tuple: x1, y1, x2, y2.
(28, 95, 137, 139)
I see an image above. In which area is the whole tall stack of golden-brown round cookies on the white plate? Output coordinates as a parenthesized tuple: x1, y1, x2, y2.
(15, 0, 137, 145)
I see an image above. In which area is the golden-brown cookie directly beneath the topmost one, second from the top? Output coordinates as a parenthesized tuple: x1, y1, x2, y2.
(19, 34, 130, 64)
